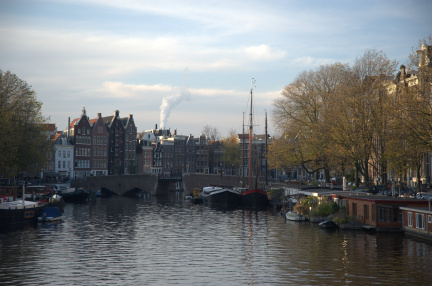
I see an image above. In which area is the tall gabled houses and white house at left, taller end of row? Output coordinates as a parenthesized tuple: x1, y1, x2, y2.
(43, 108, 137, 179)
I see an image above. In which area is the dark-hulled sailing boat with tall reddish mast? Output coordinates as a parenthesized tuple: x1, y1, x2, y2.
(240, 79, 270, 209)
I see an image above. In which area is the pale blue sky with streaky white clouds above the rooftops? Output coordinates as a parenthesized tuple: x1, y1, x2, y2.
(0, 0, 432, 137)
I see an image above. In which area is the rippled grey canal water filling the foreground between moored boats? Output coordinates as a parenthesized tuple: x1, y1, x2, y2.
(0, 195, 432, 285)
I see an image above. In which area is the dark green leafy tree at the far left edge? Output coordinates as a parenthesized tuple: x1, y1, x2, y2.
(0, 70, 49, 177)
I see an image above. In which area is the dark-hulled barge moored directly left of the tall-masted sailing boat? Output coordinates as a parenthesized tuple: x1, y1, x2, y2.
(200, 186, 240, 207)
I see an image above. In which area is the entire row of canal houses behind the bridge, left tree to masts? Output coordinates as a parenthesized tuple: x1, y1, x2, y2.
(42, 108, 274, 180)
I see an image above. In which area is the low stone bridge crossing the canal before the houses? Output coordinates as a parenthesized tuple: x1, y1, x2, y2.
(77, 174, 246, 196)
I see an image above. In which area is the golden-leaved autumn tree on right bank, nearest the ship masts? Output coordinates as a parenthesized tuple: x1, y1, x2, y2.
(269, 63, 348, 182)
